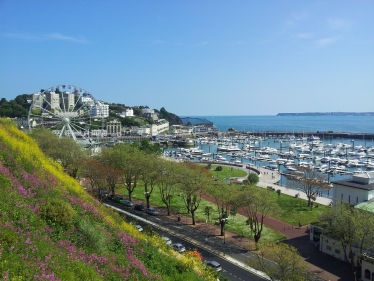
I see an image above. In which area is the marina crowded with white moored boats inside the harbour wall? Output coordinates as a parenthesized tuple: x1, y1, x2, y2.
(163, 133, 374, 197)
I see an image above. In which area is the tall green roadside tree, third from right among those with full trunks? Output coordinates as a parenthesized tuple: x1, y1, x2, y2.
(180, 162, 211, 225)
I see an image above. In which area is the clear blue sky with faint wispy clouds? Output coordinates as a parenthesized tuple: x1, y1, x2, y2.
(0, 0, 374, 116)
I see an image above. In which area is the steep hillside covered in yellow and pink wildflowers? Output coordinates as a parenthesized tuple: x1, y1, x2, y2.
(0, 119, 215, 281)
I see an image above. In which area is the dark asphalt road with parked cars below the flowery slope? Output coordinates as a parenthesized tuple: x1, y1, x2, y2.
(104, 200, 266, 281)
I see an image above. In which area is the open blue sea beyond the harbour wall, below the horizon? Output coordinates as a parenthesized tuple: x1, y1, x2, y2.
(184, 115, 374, 134)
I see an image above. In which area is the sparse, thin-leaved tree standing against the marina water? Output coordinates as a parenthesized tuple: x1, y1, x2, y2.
(287, 166, 332, 208)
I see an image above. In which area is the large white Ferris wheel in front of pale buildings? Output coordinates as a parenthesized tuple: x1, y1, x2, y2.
(28, 85, 96, 140)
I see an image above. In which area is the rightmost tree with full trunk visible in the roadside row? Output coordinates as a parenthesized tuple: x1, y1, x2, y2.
(239, 185, 280, 244)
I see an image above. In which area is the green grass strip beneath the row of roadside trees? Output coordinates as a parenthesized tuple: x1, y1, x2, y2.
(117, 185, 285, 241)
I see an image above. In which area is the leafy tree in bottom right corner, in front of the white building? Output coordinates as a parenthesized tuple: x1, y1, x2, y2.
(319, 202, 374, 280)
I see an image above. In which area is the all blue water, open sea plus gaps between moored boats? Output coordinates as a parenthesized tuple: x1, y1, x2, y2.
(164, 115, 374, 198)
